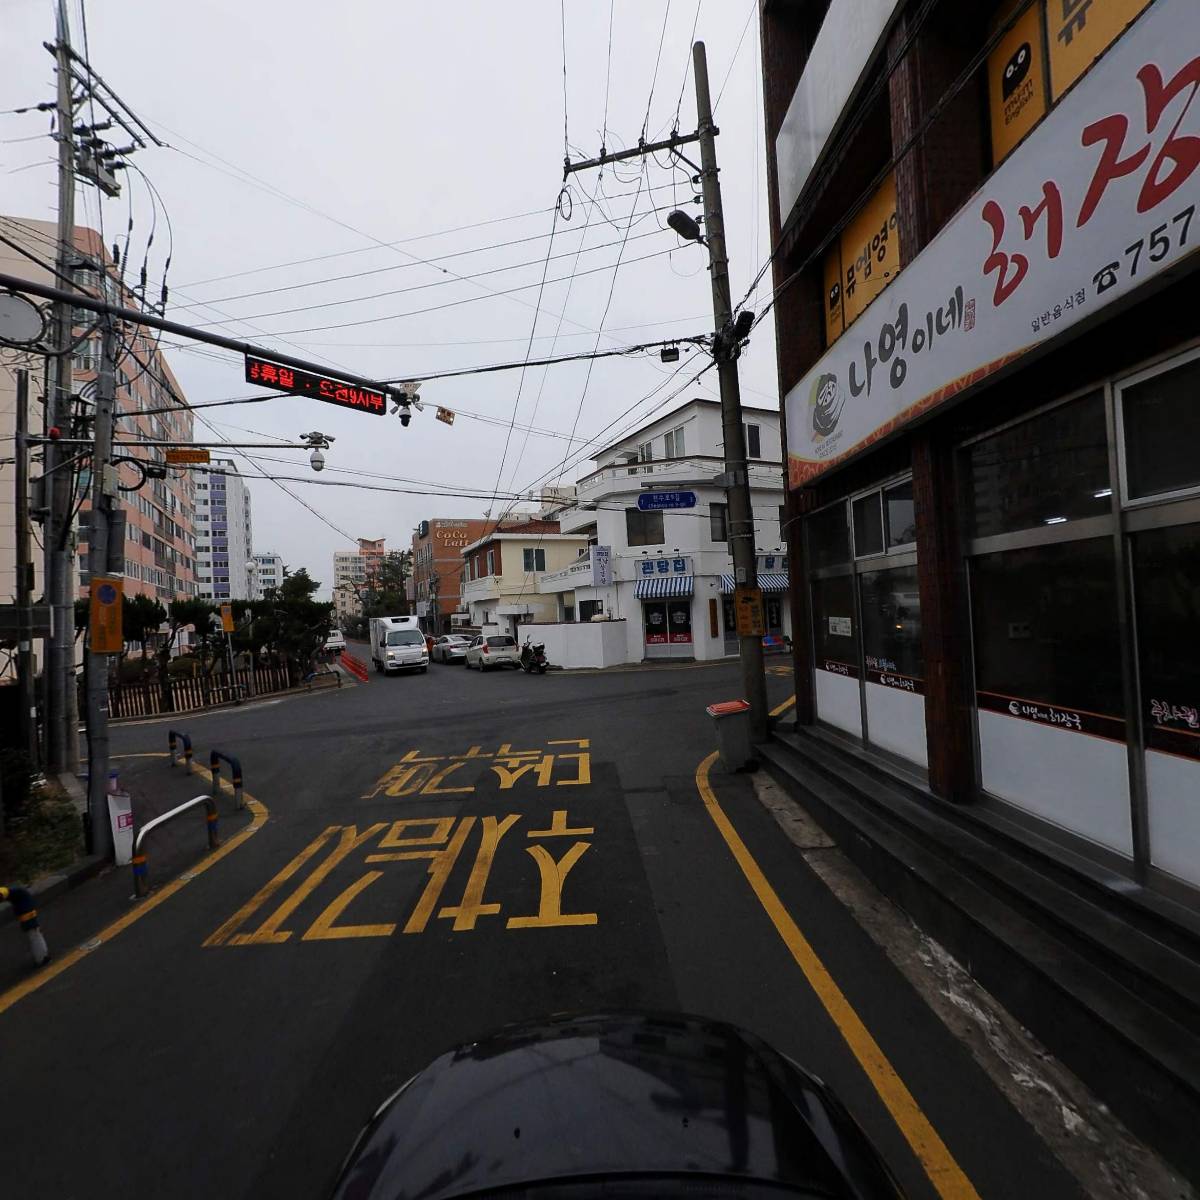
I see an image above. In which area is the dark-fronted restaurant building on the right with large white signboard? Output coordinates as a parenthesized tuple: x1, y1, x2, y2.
(762, 0, 1200, 906)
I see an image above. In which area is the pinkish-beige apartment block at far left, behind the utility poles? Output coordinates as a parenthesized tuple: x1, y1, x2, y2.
(0, 217, 198, 619)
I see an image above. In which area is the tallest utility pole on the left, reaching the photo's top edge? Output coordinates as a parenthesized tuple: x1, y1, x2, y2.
(43, 0, 79, 773)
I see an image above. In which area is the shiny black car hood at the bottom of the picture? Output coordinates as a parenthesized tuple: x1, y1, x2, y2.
(335, 1014, 899, 1200)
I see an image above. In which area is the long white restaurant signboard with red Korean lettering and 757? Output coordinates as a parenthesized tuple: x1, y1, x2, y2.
(785, 0, 1200, 487)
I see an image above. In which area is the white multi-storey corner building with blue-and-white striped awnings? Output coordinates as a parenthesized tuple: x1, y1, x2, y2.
(538, 400, 791, 667)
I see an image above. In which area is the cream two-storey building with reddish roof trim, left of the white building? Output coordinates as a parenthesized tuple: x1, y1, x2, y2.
(461, 516, 588, 637)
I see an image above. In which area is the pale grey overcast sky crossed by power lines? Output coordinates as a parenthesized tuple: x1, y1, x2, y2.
(0, 0, 778, 594)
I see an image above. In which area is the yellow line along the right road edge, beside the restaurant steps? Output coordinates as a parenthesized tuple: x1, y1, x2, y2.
(696, 744, 979, 1200)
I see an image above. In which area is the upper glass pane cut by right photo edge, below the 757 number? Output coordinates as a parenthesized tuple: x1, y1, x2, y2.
(1121, 359, 1200, 498)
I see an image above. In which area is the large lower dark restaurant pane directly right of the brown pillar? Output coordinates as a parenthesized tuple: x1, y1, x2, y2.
(971, 538, 1124, 724)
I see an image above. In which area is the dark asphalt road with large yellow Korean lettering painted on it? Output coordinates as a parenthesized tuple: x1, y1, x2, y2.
(0, 665, 1080, 1200)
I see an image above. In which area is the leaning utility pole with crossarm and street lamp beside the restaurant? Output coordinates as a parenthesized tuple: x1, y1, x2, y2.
(564, 42, 770, 742)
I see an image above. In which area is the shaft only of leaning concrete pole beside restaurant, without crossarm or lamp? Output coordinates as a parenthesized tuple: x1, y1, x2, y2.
(691, 42, 769, 742)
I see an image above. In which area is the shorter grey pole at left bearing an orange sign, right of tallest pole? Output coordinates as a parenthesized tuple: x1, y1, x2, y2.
(88, 317, 116, 858)
